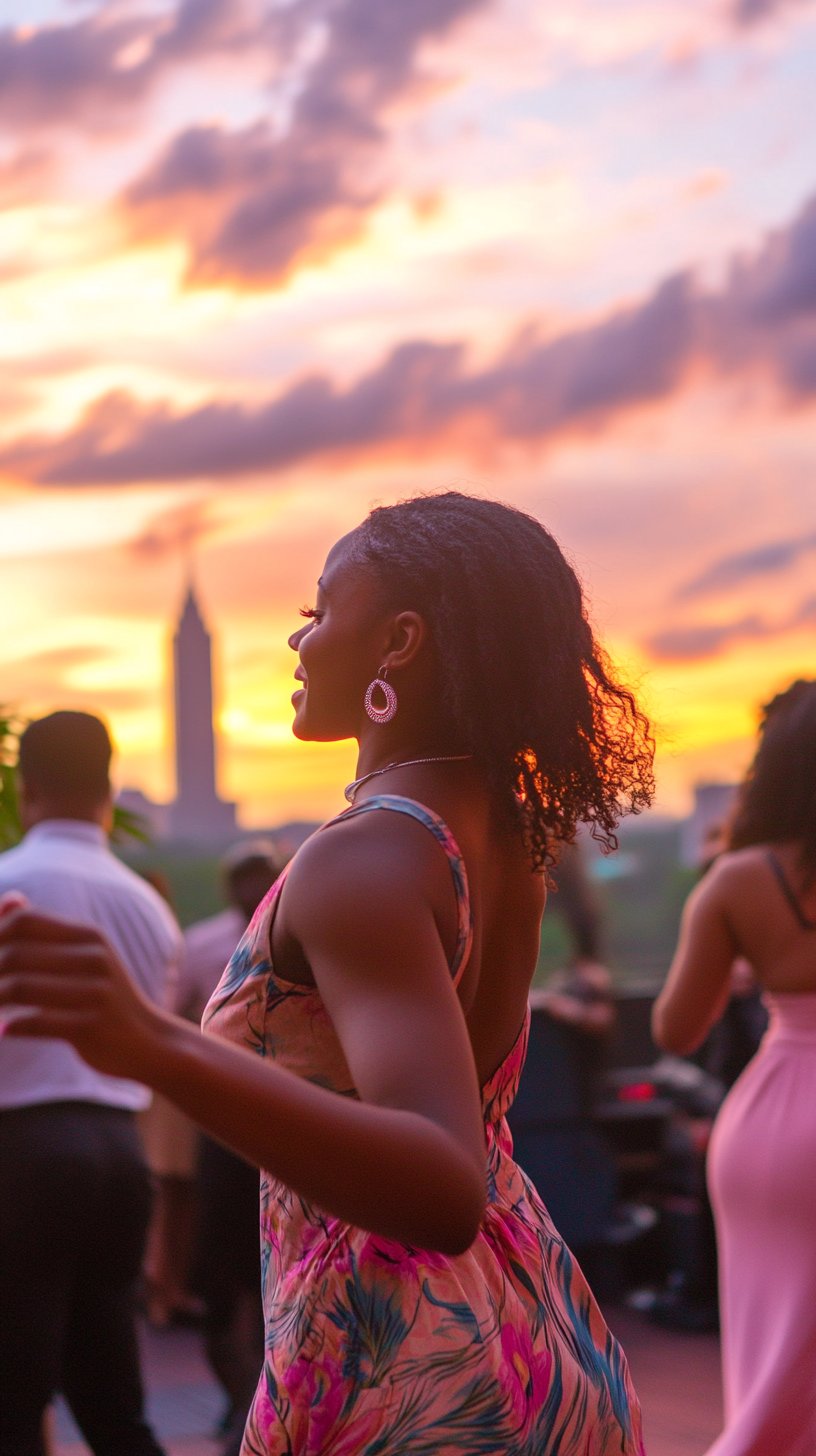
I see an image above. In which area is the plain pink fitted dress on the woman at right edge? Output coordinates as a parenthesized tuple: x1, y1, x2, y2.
(708, 994, 816, 1456)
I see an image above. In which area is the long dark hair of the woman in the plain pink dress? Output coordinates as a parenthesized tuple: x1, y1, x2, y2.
(729, 677, 816, 874)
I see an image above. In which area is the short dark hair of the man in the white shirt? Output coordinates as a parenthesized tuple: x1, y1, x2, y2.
(19, 711, 114, 804)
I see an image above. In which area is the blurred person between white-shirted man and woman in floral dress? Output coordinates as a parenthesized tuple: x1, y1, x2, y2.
(177, 839, 283, 1456)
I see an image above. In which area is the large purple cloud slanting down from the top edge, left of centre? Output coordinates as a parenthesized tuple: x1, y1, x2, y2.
(121, 0, 491, 287)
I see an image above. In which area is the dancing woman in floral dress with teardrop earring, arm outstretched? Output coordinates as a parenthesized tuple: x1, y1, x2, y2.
(0, 492, 651, 1456)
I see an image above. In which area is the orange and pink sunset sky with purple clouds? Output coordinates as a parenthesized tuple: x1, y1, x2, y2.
(0, 0, 816, 824)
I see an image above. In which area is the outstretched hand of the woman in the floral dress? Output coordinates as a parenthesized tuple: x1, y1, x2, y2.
(0, 900, 163, 1080)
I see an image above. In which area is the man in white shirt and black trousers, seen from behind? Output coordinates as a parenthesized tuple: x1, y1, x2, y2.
(0, 712, 181, 1456)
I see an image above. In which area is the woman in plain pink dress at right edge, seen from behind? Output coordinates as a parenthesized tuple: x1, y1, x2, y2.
(654, 681, 816, 1456)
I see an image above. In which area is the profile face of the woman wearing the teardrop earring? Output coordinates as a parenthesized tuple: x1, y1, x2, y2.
(289, 536, 388, 743)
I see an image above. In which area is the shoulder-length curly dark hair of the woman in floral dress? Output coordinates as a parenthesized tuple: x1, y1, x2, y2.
(356, 491, 654, 869)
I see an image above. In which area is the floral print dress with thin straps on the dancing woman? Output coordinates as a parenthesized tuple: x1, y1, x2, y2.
(203, 795, 643, 1456)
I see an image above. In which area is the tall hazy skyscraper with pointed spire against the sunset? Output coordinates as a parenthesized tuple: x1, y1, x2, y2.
(170, 584, 236, 844)
